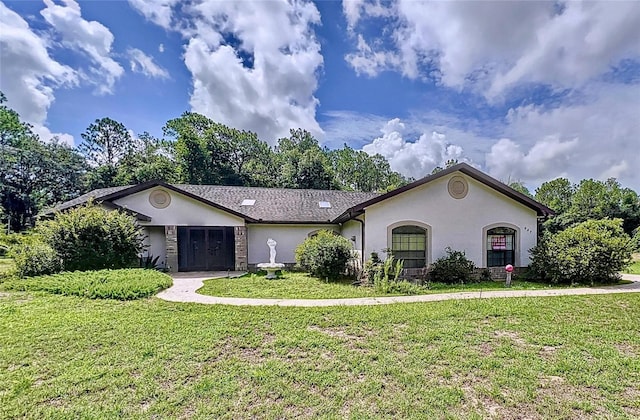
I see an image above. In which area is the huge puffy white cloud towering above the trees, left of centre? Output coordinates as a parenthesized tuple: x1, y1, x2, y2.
(131, 0, 323, 144)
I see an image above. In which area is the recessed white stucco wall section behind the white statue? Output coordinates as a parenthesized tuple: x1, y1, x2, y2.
(247, 224, 340, 264)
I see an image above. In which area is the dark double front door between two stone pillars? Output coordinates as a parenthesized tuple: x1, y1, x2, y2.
(178, 226, 235, 271)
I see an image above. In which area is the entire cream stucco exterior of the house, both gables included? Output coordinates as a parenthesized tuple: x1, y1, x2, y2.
(92, 171, 537, 267)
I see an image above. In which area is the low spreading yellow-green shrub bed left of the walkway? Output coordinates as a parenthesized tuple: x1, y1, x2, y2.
(4, 269, 172, 300)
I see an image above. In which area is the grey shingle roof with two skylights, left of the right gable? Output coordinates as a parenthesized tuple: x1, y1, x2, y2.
(52, 182, 379, 223)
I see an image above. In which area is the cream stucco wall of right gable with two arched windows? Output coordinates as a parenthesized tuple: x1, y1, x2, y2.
(365, 172, 537, 267)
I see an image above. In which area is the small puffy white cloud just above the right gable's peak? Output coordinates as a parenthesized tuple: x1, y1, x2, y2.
(362, 118, 469, 178)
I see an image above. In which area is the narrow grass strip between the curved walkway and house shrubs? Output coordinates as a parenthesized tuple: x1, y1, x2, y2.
(198, 273, 564, 299)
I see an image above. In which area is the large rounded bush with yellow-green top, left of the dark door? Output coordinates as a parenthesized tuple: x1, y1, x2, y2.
(37, 204, 143, 271)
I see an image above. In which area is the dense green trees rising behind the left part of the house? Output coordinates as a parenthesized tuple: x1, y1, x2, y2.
(0, 92, 411, 231)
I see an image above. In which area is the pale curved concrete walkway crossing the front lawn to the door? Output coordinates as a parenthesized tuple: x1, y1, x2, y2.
(157, 271, 640, 307)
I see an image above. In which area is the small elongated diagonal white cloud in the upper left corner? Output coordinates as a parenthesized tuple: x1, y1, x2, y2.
(40, 0, 124, 94)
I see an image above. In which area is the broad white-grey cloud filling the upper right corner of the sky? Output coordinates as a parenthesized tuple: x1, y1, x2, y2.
(343, 0, 640, 98)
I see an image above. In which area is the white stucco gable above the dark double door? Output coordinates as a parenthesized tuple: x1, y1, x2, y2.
(114, 187, 244, 226)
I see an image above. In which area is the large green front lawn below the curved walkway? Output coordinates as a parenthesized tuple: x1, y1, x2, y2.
(0, 292, 640, 419)
